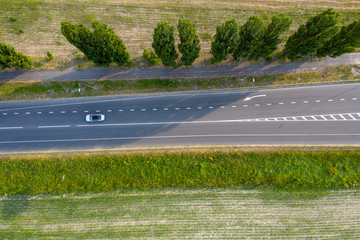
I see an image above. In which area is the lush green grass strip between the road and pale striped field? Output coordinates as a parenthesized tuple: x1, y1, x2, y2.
(0, 151, 360, 195)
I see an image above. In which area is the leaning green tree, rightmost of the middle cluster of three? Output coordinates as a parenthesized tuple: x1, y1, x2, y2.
(250, 13, 292, 60)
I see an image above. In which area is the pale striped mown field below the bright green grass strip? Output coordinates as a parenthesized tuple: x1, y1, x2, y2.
(0, 188, 360, 239)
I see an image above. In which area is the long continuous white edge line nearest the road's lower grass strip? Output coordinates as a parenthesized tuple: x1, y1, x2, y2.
(0, 133, 360, 144)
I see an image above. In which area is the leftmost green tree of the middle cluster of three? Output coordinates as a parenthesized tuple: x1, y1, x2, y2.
(210, 19, 239, 62)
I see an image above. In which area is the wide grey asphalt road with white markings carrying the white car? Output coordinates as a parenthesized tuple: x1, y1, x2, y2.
(0, 83, 360, 151)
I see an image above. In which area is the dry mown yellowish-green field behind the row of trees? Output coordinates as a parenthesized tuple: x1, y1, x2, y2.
(0, 0, 360, 68)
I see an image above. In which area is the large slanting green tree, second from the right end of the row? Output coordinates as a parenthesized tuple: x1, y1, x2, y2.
(285, 9, 341, 61)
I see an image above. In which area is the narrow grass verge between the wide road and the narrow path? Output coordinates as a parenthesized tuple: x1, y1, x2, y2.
(0, 65, 360, 101)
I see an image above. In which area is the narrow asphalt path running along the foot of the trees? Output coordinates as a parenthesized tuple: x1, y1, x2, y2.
(0, 52, 360, 82)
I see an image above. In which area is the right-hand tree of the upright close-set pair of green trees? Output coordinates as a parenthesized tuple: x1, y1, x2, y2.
(177, 18, 200, 66)
